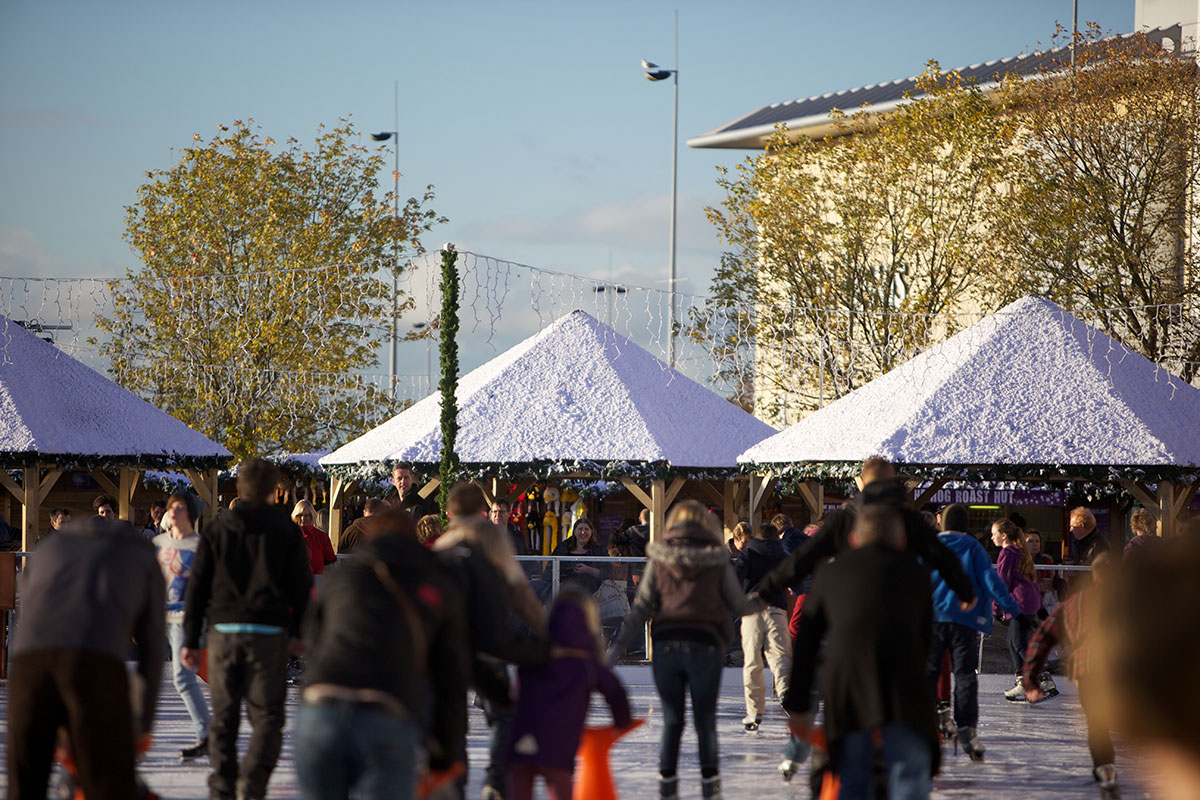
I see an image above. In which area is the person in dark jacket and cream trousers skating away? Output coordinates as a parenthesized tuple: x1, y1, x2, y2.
(733, 525, 792, 732)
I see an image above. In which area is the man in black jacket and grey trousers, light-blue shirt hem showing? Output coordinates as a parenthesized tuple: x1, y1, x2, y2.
(181, 458, 312, 800)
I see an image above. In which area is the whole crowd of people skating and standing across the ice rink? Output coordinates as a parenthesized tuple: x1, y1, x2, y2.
(7, 458, 1200, 800)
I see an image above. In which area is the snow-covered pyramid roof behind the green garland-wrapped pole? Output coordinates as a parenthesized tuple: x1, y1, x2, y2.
(320, 311, 775, 468)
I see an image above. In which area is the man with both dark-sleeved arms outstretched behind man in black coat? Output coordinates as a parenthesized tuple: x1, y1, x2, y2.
(758, 456, 976, 608)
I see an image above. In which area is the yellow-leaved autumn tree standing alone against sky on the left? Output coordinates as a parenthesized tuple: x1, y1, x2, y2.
(100, 120, 444, 458)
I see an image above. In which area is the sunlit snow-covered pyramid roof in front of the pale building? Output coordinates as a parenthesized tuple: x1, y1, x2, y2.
(738, 297, 1200, 467)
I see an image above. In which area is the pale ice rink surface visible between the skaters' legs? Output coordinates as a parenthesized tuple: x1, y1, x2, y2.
(0, 664, 1145, 800)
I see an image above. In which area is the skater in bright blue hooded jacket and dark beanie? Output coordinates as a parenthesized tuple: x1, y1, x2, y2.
(928, 504, 1020, 760)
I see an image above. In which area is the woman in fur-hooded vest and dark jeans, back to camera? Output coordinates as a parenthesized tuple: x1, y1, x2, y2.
(608, 500, 762, 800)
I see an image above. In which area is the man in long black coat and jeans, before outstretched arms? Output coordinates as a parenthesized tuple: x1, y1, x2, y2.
(784, 504, 938, 798)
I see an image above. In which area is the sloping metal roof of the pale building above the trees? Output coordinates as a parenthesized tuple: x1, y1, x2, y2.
(688, 25, 1183, 150)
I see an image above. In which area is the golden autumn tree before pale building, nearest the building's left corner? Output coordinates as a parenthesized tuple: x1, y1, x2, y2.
(691, 62, 1013, 422)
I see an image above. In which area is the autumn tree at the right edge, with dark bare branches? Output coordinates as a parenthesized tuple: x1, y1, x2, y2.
(992, 28, 1200, 380)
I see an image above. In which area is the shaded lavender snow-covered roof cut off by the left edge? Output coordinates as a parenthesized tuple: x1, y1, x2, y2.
(0, 315, 232, 467)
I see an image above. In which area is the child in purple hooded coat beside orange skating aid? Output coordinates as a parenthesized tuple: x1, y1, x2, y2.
(509, 587, 630, 800)
